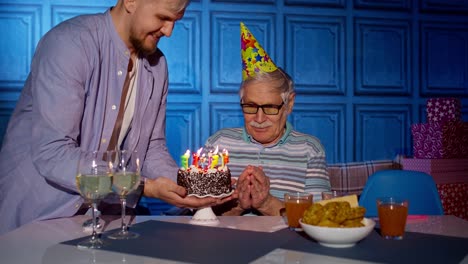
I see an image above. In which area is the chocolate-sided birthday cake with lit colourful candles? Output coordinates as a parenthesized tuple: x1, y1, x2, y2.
(177, 147, 232, 196)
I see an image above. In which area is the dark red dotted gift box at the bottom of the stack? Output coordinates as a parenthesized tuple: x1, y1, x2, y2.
(436, 182, 468, 221)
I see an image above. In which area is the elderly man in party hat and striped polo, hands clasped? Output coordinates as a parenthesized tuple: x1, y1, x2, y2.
(206, 23, 330, 215)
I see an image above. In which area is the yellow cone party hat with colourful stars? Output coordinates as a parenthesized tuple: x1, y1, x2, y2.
(241, 22, 278, 80)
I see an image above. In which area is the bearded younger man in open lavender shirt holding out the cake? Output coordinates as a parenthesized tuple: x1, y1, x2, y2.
(0, 0, 229, 234)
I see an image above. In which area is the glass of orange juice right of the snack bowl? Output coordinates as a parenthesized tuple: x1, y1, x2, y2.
(377, 197, 408, 240)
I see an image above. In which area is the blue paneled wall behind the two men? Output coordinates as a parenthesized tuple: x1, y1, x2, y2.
(0, 0, 468, 213)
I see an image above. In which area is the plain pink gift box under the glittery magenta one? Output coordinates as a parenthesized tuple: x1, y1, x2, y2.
(400, 158, 468, 184)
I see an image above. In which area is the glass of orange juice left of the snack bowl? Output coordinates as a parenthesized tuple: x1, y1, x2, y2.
(284, 192, 313, 231)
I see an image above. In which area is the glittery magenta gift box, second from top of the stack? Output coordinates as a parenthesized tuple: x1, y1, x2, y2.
(411, 121, 468, 159)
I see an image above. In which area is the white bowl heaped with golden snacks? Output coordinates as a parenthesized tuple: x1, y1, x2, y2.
(299, 195, 375, 248)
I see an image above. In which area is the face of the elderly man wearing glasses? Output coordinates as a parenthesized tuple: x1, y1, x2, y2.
(242, 82, 294, 145)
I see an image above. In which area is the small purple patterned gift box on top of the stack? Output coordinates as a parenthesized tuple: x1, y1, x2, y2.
(426, 97, 462, 123)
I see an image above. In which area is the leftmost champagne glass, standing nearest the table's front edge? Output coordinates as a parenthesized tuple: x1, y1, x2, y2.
(76, 151, 115, 248)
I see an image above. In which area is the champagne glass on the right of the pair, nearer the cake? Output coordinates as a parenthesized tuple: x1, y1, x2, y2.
(108, 150, 141, 239)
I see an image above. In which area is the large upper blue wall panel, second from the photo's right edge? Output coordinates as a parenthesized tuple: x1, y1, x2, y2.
(355, 18, 411, 95)
